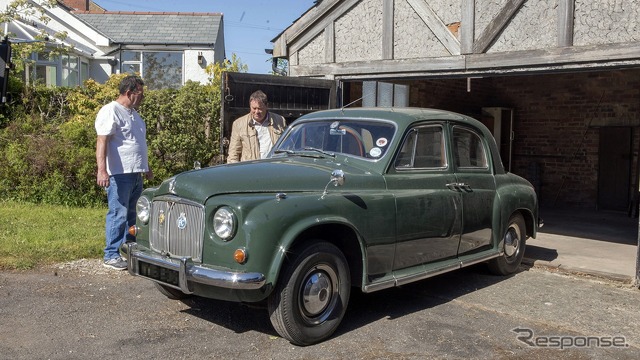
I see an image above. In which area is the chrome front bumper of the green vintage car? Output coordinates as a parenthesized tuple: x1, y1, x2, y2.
(122, 242, 265, 294)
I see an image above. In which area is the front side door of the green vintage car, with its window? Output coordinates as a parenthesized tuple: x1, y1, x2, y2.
(387, 124, 462, 270)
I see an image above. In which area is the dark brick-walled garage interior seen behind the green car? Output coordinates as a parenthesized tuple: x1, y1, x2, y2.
(343, 69, 640, 217)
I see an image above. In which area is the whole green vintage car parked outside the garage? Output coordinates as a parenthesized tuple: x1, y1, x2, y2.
(123, 108, 539, 345)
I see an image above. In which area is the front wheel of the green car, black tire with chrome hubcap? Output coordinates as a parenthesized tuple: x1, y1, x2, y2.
(268, 242, 351, 346)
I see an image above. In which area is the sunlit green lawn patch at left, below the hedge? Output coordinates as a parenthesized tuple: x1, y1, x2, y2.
(0, 202, 107, 269)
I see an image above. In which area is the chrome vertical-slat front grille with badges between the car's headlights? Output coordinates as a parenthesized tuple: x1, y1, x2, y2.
(149, 198, 204, 262)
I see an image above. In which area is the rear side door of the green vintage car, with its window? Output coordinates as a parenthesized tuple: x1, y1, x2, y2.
(451, 125, 496, 255)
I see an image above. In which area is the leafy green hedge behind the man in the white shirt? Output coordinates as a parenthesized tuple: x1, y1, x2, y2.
(0, 57, 245, 206)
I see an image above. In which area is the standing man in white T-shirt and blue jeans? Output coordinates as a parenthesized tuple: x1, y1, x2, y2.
(95, 75, 153, 270)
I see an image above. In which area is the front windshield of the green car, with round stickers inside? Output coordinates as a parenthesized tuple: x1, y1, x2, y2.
(274, 120, 395, 159)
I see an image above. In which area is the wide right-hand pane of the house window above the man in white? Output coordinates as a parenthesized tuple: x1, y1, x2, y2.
(142, 52, 182, 89)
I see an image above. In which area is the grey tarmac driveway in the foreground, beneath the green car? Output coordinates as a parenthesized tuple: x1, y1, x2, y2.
(0, 260, 640, 360)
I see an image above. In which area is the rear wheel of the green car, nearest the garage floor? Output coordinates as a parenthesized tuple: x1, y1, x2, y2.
(489, 214, 527, 275)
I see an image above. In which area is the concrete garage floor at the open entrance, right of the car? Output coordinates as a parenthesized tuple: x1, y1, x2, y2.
(525, 208, 638, 283)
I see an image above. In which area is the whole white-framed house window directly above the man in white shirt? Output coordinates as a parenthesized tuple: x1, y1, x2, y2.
(120, 50, 184, 89)
